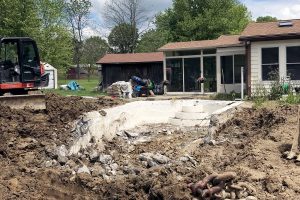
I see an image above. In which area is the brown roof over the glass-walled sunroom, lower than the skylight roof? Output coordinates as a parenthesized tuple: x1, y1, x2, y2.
(159, 35, 242, 51)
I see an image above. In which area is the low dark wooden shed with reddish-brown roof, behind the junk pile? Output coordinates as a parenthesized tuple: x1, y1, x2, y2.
(97, 52, 164, 88)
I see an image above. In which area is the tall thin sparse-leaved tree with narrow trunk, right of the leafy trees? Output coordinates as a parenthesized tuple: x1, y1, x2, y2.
(66, 0, 92, 79)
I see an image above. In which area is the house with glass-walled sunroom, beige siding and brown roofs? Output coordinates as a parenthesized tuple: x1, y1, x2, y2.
(159, 20, 300, 95)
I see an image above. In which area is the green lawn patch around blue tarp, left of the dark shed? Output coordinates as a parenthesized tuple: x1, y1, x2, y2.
(44, 77, 105, 97)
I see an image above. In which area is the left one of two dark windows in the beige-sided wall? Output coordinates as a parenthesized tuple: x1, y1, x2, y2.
(262, 47, 279, 81)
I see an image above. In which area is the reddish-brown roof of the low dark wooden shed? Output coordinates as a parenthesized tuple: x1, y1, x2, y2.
(97, 52, 164, 64)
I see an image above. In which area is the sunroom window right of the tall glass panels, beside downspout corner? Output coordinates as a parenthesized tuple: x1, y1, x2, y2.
(221, 55, 245, 84)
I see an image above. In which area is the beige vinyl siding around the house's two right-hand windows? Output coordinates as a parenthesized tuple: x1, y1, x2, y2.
(251, 39, 300, 94)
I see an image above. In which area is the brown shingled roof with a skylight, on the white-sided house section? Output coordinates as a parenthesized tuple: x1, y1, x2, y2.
(240, 19, 300, 41)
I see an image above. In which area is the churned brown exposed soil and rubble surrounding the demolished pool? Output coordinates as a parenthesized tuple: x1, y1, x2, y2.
(0, 95, 300, 199)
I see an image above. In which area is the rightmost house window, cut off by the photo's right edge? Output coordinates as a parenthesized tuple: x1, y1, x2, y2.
(286, 46, 300, 80)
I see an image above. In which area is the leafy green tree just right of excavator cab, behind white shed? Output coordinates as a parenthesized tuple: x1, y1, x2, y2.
(35, 0, 73, 75)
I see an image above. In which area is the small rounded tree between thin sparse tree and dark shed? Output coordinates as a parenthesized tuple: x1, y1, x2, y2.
(82, 36, 109, 80)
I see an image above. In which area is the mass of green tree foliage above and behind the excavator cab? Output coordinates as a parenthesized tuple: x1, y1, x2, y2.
(0, 0, 72, 75)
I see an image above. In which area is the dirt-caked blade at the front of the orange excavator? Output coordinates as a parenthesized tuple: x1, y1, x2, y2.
(0, 94, 46, 110)
